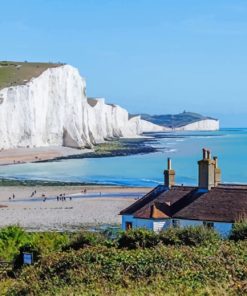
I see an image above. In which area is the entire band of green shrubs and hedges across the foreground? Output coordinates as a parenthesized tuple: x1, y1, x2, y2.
(0, 227, 247, 295)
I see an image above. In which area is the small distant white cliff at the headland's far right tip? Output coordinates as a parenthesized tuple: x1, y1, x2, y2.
(175, 119, 219, 131)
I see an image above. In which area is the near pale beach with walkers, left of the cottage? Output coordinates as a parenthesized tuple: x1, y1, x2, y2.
(0, 186, 150, 231)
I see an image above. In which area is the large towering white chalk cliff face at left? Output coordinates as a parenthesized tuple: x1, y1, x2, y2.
(0, 65, 162, 149)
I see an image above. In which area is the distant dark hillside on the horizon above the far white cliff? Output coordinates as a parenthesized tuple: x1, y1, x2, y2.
(141, 111, 218, 128)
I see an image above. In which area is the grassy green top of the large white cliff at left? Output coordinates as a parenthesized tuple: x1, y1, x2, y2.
(0, 61, 62, 90)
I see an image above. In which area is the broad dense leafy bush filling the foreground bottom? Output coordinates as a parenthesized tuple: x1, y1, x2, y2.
(7, 241, 247, 295)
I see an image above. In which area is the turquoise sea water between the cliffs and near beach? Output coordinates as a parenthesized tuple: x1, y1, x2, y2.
(0, 129, 247, 186)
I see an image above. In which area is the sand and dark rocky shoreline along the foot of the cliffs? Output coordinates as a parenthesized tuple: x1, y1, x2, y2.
(0, 136, 159, 166)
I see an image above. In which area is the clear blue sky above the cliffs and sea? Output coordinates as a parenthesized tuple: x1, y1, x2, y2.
(0, 0, 247, 127)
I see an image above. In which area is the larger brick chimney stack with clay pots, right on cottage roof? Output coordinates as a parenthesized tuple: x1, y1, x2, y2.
(198, 148, 215, 190)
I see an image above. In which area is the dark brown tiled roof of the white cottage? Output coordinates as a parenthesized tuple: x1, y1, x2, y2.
(120, 184, 247, 222)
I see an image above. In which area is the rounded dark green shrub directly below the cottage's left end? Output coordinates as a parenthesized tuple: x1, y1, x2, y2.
(117, 228, 160, 249)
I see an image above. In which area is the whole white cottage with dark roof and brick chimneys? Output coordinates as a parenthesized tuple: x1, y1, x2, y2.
(120, 149, 247, 236)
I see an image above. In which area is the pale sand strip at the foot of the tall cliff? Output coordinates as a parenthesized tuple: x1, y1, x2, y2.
(0, 146, 90, 165)
